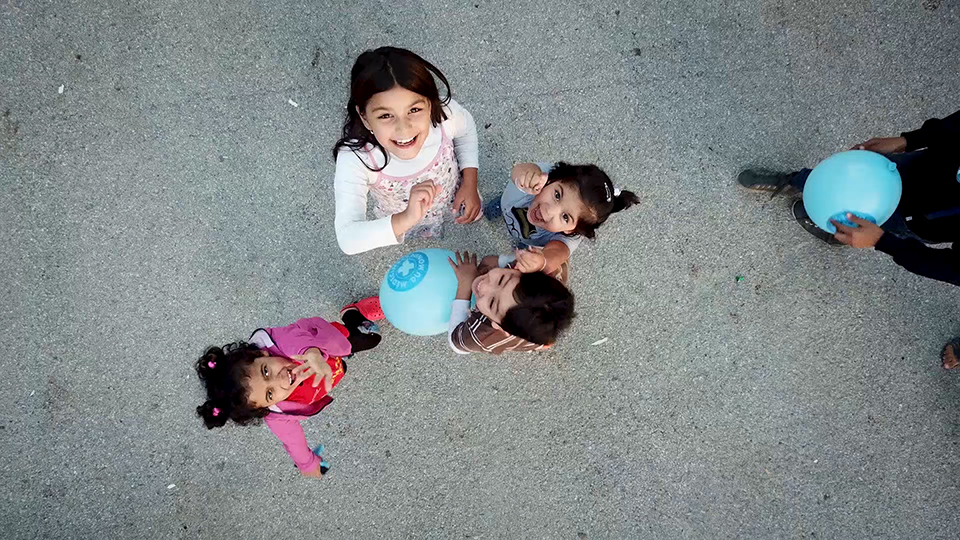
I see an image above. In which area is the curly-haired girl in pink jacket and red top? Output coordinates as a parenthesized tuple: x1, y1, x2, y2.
(196, 308, 380, 478)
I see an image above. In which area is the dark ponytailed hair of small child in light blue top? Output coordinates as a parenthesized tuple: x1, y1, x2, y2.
(547, 161, 640, 238)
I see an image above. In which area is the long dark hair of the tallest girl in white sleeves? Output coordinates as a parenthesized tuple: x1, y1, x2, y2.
(333, 47, 450, 171)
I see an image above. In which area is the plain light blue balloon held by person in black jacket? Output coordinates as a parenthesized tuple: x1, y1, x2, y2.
(803, 150, 903, 233)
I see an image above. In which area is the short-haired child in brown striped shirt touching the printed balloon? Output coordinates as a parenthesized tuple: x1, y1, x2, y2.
(448, 252, 574, 354)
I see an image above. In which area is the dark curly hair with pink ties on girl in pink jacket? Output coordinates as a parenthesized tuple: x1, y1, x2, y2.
(196, 341, 270, 429)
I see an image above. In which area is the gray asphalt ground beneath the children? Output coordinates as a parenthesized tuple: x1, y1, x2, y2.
(0, 0, 960, 540)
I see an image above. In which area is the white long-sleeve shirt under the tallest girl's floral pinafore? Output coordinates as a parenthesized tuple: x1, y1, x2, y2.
(333, 100, 479, 255)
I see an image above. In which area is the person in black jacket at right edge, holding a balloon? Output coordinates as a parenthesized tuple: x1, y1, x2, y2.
(737, 111, 960, 285)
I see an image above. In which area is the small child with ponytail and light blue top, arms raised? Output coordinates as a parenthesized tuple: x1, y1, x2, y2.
(484, 161, 639, 274)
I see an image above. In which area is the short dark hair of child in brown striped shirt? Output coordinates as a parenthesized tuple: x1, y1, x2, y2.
(500, 272, 575, 345)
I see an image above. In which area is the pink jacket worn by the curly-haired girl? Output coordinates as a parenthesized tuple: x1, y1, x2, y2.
(250, 317, 350, 472)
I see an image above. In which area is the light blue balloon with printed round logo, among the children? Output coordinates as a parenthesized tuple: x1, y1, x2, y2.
(380, 249, 457, 336)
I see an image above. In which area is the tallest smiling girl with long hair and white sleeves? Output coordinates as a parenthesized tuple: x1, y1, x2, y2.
(333, 47, 482, 255)
